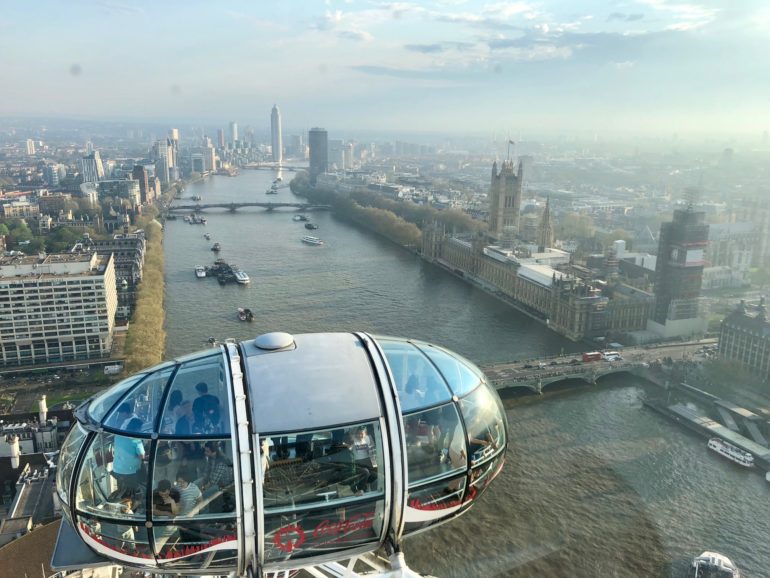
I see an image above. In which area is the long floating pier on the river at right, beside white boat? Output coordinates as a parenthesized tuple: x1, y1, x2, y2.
(643, 386, 770, 470)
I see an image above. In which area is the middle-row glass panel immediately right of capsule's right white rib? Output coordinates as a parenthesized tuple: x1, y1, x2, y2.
(404, 403, 468, 486)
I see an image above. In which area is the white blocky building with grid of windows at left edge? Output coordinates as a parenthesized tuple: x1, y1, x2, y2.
(0, 253, 118, 366)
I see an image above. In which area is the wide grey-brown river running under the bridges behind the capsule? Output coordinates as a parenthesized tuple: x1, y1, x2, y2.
(164, 171, 770, 578)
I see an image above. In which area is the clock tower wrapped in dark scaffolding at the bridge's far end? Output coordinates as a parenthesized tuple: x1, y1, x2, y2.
(649, 204, 709, 338)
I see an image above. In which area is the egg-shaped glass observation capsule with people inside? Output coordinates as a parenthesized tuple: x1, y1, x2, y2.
(53, 333, 507, 575)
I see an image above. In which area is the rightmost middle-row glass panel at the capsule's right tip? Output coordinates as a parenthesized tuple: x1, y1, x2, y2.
(460, 384, 506, 466)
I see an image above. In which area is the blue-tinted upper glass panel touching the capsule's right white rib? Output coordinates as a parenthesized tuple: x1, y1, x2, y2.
(377, 338, 452, 413)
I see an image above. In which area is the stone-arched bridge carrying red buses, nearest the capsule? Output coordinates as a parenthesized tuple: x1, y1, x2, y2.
(481, 339, 715, 393)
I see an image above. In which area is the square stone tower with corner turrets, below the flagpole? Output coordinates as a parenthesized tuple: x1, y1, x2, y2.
(489, 160, 524, 241)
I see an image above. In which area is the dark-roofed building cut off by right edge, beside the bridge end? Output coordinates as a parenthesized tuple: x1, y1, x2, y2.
(719, 298, 770, 381)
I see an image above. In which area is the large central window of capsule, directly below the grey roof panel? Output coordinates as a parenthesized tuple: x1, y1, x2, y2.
(262, 422, 385, 510)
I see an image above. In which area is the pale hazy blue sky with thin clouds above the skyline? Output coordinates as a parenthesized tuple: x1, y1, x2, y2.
(0, 0, 770, 135)
